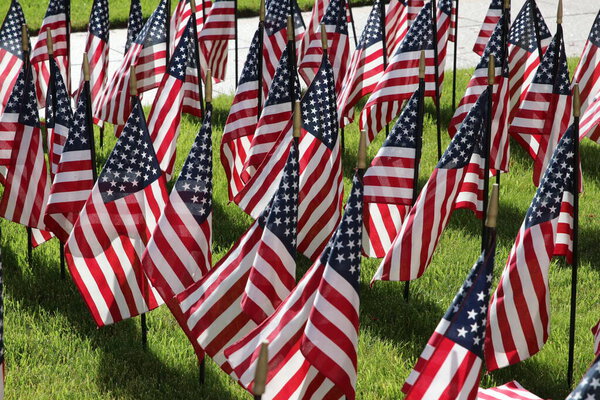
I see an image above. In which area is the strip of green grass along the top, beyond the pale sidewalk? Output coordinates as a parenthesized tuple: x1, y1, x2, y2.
(5, 0, 372, 33)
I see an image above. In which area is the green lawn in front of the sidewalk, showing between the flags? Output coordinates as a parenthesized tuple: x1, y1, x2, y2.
(0, 61, 600, 400)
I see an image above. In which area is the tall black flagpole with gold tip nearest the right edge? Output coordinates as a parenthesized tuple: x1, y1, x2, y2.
(567, 85, 581, 388)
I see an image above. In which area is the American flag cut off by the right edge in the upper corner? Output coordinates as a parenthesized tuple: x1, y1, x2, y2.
(573, 11, 600, 113)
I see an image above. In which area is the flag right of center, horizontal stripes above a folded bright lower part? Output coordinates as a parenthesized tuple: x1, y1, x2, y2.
(362, 90, 422, 258)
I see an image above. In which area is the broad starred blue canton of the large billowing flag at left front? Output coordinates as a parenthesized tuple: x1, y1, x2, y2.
(98, 100, 161, 203)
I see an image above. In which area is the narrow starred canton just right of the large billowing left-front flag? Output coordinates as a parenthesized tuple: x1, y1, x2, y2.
(175, 103, 212, 224)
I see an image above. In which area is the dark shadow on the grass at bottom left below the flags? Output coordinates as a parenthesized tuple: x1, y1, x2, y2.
(2, 241, 241, 399)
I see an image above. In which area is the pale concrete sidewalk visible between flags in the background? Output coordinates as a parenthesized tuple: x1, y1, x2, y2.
(44, 0, 600, 105)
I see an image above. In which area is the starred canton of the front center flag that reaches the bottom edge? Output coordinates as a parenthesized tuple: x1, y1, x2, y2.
(321, 174, 363, 292)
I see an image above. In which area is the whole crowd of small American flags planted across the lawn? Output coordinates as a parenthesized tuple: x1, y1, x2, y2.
(0, 0, 600, 399)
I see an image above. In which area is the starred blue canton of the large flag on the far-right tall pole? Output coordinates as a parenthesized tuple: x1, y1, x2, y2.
(525, 125, 577, 228)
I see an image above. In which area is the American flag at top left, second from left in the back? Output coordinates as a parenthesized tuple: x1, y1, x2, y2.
(31, 0, 71, 107)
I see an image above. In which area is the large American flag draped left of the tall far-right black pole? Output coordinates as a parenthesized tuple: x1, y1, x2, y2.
(485, 126, 577, 371)
